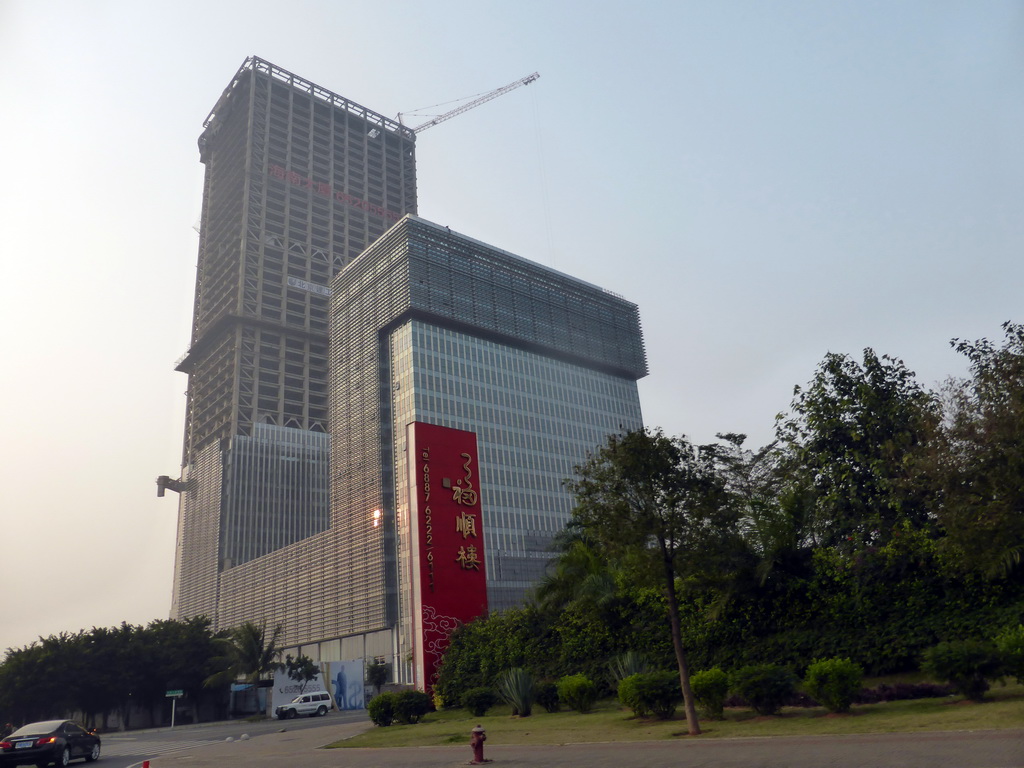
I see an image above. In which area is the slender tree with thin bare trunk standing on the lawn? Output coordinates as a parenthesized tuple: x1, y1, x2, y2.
(566, 430, 735, 735)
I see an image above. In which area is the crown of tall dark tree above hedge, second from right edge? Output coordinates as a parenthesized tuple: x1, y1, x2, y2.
(776, 349, 939, 551)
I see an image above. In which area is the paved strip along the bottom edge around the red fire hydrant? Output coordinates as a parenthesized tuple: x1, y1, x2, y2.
(151, 723, 1024, 768)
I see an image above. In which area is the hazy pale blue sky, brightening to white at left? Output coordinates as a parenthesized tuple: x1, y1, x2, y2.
(0, 0, 1024, 651)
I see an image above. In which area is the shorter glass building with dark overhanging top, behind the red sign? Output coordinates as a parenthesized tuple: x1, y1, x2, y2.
(330, 216, 647, 679)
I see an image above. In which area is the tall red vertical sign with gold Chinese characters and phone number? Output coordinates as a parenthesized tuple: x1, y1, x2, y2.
(408, 422, 487, 693)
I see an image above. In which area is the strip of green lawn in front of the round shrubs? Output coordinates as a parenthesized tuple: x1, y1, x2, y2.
(329, 684, 1024, 748)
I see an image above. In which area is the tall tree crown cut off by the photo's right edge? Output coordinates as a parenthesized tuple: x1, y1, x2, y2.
(933, 323, 1024, 575)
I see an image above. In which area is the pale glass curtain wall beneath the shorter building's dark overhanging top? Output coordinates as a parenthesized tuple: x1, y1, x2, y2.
(389, 321, 643, 667)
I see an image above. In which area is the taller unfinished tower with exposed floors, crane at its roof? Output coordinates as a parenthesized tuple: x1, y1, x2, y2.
(171, 57, 416, 627)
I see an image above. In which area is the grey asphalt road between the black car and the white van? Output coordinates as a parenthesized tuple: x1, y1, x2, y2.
(101, 710, 367, 768)
